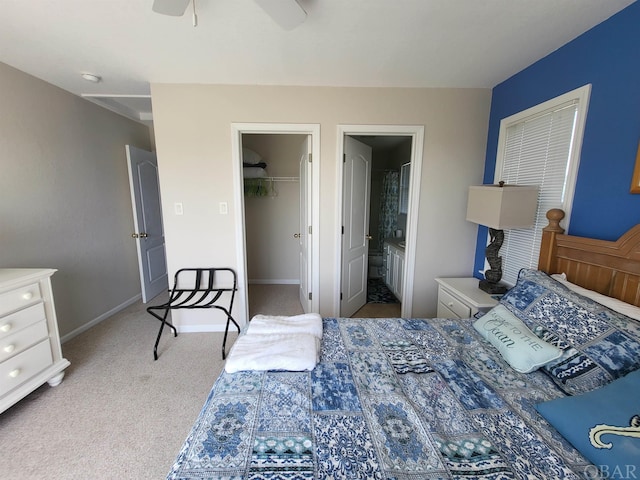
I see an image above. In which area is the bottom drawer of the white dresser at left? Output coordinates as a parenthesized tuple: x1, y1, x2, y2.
(0, 339, 53, 393)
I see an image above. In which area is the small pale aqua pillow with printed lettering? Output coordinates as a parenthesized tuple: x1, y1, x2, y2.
(473, 304, 562, 373)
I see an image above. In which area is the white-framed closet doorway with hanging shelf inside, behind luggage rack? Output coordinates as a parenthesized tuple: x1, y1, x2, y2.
(234, 125, 318, 326)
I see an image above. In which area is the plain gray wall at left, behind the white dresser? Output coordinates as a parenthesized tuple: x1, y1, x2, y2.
(0, 63, 150, 336)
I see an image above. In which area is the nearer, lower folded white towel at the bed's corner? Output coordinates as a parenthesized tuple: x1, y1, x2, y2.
(224, 334, 320, 373)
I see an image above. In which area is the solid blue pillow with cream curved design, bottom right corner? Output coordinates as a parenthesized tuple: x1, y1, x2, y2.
(536, 370, 640, 478)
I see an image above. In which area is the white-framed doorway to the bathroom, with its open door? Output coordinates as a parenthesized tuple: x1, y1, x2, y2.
(337, 126, 423, 317)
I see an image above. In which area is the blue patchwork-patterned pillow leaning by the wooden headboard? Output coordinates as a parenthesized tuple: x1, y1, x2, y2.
(500, 269, 640, 395)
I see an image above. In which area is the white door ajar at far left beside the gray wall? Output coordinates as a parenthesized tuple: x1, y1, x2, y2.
(126, 145, 168, 303)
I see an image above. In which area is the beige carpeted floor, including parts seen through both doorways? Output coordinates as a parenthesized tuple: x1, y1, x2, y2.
(0, 285, 399, 480)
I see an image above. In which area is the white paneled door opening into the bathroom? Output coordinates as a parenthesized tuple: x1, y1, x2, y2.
(340, 136, 371, 317)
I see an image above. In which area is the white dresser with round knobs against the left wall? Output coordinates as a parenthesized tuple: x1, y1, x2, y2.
(0, 268, 69, 413)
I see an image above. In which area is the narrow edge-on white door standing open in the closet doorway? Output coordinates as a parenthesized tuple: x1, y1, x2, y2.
(298, 136, 313, 313)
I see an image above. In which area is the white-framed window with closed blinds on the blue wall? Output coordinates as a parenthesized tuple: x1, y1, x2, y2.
(494, 85, 591, 284)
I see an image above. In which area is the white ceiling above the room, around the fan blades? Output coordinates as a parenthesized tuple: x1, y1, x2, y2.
(0, 0, 633, 124)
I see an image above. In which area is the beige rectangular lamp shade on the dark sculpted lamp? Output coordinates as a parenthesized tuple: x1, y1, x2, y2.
(467, 185, 538, 230)
